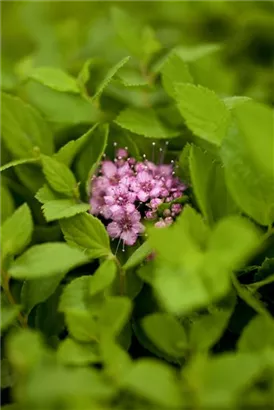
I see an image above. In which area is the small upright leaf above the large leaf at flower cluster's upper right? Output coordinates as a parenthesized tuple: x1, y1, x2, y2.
(161, 52, 193, 98)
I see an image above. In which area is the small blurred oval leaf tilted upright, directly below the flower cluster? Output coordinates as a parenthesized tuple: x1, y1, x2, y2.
(99, 296, 132, 337)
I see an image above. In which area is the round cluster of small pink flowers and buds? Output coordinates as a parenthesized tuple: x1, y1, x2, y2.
(90, 148, 186, 245)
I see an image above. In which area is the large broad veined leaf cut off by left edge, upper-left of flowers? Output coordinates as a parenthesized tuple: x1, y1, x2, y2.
(1, 93, 53, 158)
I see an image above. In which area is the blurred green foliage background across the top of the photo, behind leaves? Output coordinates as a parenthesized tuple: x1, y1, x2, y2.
(1, 0, 274, 104)
